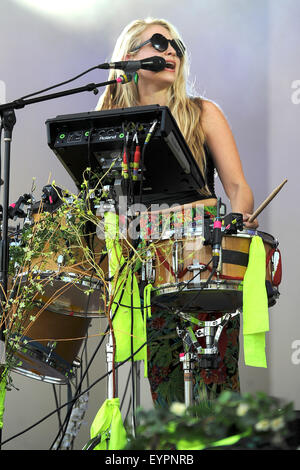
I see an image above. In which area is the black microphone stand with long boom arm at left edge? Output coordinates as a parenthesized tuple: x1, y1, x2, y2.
(0, 75, 132, 449)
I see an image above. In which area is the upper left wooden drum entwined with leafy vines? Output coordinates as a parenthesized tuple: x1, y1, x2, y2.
(17, 203, 108, 317)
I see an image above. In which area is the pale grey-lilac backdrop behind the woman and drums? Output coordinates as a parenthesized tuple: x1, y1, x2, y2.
(0, 0, 300, 449)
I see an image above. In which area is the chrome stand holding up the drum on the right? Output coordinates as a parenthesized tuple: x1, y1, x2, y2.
(176, 310, 240, 408)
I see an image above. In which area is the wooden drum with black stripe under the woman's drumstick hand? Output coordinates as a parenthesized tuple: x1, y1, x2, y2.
(143, 205, 279, 312)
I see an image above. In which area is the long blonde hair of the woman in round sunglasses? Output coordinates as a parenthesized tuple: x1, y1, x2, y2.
(96, 18, 211, 196)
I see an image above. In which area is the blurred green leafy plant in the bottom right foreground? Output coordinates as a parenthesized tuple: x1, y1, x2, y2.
(126, 391, 294, 450)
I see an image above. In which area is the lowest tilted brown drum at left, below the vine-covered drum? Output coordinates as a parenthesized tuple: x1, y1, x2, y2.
(12, 307, 90, 385)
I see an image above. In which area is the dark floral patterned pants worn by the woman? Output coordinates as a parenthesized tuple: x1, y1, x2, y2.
(147, 309, 240, 407)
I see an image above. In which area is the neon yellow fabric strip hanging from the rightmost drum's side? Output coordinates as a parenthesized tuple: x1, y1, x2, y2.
(243, 236, 269, 367)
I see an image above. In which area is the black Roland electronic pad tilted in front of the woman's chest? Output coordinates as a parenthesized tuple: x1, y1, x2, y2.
(46, 105, 204, 204)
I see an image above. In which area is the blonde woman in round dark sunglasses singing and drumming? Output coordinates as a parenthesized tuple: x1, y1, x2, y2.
(96, 18, 258, 406)
